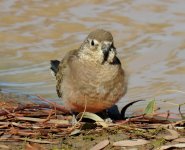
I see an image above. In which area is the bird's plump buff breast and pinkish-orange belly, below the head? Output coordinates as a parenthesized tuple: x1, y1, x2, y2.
(62, 59, 125, 112)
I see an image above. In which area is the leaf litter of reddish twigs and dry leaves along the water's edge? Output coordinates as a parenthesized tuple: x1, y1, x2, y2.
(0, 92, 185, 150)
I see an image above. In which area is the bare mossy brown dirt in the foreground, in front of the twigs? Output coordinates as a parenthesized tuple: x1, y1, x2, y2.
(0, 126, 185, 150)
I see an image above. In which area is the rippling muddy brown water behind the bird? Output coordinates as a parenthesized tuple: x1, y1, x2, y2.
(0, 0, 185, 112)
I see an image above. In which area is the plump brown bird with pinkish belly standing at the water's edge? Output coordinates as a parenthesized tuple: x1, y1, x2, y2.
(50, 29, 127, 113)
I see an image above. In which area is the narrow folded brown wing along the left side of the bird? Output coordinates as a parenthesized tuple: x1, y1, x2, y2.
(56, 49, 78, 97)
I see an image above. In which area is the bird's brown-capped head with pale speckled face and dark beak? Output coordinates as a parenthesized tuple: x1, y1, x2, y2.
(79, 29, 116, 64)
